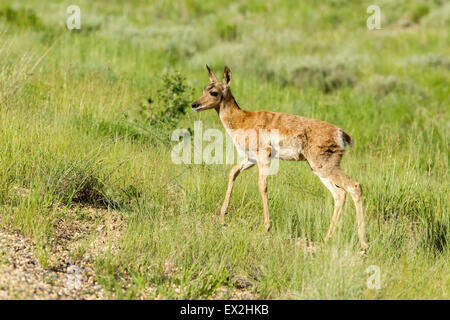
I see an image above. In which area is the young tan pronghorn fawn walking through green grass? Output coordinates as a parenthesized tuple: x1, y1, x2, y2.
(192, 66, 367, 250)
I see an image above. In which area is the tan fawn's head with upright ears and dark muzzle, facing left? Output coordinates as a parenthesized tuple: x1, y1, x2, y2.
(192, 65, 231, 112)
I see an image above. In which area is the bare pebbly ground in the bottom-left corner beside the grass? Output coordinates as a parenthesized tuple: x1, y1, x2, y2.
(0, 230, 105, 299)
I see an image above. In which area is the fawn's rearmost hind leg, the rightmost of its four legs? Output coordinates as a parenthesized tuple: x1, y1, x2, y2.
(325, 167, 368, 250)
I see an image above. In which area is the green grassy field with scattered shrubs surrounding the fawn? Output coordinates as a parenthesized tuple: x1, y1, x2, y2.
(0, 0, 450, 299)
